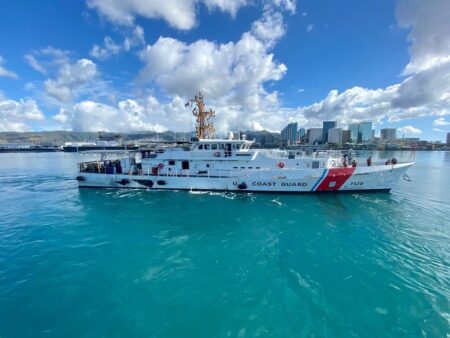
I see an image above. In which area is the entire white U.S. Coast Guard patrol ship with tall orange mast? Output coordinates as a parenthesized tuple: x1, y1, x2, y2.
(76, 94, 414, 193)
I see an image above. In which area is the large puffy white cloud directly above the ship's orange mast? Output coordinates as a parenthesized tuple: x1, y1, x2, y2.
(139, 33, 286, 101)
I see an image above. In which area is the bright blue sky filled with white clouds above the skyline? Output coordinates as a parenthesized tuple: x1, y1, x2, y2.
(0, 0, 450, 141)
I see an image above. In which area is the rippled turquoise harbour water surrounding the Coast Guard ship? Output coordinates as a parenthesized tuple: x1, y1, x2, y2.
(0, 152, 450, 338)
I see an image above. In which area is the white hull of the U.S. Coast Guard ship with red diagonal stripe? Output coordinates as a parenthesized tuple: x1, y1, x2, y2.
(77, 163, 413, 193)
